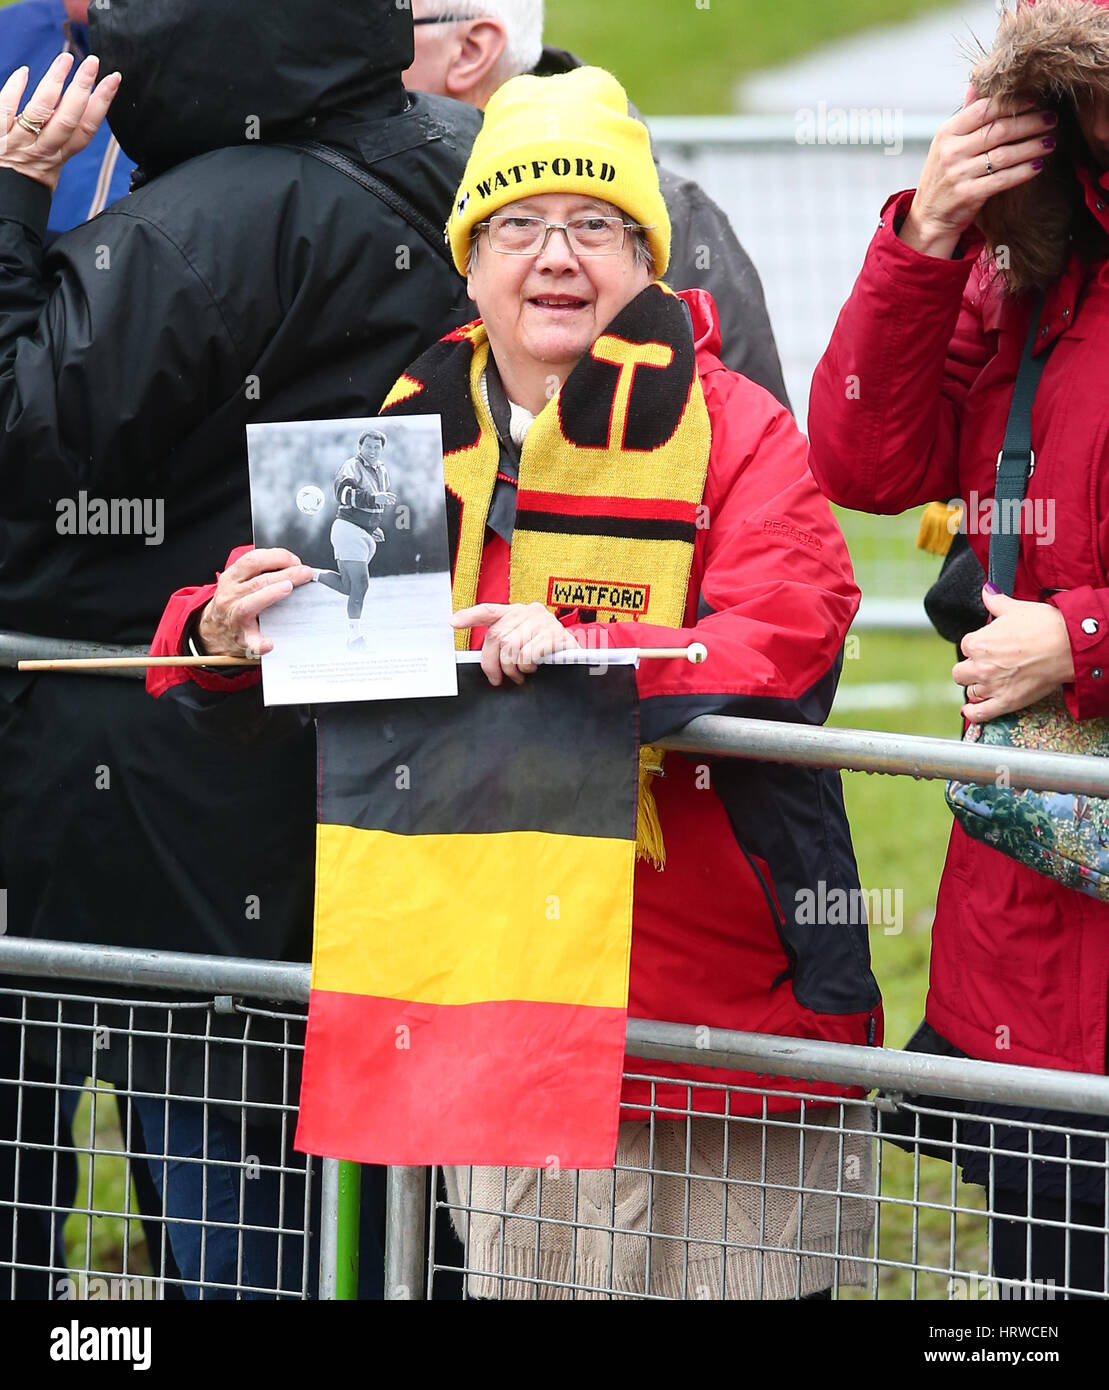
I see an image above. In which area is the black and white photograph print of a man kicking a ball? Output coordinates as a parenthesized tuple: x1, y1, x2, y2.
(246, 416, 457, 705)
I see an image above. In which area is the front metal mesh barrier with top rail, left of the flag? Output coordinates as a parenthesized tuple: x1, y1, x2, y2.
(0, 940, 323, 1300)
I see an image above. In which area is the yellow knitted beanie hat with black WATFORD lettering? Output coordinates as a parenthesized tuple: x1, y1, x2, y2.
(446, 68, 670, 277)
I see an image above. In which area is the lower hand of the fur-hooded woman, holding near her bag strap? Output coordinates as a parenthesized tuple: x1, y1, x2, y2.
(951, 588, 1074, 724)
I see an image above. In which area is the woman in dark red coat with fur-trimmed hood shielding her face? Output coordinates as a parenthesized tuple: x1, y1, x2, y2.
(809, 0, 1109, 1293)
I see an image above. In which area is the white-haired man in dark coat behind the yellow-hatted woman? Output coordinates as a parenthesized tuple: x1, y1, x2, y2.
(403, 0, 789, 406)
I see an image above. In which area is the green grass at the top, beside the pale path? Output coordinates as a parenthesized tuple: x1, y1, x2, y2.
(546, 0, 967, 115)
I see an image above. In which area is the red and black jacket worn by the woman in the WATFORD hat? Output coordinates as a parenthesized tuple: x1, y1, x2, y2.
(149, 291, 881, 1118)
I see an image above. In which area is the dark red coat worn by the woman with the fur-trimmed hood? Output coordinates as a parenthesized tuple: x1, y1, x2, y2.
(809, 172, 1109, 1072)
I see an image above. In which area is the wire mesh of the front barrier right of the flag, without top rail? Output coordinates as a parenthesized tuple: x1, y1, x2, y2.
(428, 1073, 1109, 1301)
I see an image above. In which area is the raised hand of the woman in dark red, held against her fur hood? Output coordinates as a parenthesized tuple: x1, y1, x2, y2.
(899, 88, 1058, 257)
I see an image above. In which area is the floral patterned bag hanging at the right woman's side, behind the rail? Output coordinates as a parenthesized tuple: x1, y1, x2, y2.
(946, 691, 1109, 902)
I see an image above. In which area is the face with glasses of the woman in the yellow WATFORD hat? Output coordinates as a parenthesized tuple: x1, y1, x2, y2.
(467, 193, 652, 377)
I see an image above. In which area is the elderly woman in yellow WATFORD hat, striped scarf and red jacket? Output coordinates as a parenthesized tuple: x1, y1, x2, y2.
(158, 68, 881, 1298)
